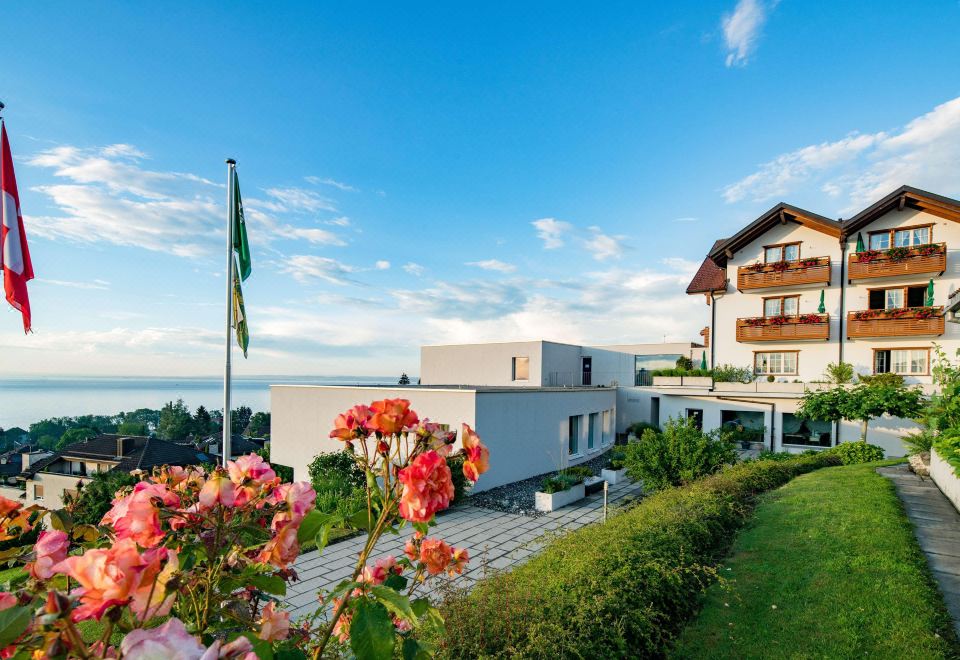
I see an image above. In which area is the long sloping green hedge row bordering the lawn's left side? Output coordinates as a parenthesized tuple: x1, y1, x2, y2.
(440, 454, 839, 658)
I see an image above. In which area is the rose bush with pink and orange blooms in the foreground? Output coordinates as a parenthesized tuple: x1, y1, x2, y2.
(0, 399, 489, 660)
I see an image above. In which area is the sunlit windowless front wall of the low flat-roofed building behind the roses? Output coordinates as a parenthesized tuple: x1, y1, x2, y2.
(270, 385, 482, 481)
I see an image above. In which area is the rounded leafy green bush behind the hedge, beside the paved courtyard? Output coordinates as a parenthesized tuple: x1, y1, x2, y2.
(625, 418, 737, 490)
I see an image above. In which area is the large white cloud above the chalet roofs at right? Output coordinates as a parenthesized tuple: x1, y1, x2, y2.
(722, 97, 960, 209)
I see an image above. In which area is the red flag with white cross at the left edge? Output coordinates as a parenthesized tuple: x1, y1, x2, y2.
(0, 121, 33, 332)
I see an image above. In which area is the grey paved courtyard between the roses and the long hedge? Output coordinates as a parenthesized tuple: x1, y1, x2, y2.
(286, 481, 641, 619)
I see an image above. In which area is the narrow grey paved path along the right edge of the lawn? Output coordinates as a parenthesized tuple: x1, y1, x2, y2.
(877, 465, 960, 635)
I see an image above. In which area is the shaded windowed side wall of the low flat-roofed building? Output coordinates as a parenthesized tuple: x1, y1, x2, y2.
(476, 388, 617, 491)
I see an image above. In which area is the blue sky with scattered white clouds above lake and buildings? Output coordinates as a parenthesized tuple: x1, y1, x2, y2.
(0, 0, 960, 377)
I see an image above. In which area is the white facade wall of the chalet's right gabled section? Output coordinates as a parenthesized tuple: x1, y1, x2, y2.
(844, 209, 960, 383)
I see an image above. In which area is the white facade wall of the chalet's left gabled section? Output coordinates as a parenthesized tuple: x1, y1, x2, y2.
(707, 222, 841, 381)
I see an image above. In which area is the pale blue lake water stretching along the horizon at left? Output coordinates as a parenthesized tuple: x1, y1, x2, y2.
(0, 376, 396, 428)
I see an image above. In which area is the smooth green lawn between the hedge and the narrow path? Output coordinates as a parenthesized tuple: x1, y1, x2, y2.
(674, 464, 960, 658)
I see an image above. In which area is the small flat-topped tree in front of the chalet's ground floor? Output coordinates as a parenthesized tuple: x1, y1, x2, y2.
(796, 383, 923, 442)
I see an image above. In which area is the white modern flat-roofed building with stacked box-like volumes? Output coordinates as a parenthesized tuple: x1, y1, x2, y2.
(270, 341, 708, 491)
